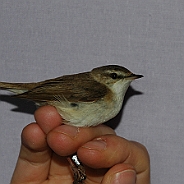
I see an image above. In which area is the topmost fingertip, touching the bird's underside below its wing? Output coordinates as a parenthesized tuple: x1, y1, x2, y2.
(34, 105, 62, 134)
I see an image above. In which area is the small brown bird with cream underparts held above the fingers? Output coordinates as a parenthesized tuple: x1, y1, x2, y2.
(0, 65, 143, 127)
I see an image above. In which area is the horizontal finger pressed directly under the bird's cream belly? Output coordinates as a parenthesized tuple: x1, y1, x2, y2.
(47, 125, 115, 156)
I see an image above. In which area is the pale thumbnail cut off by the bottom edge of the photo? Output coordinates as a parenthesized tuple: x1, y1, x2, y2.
(111, 170, 136, 184)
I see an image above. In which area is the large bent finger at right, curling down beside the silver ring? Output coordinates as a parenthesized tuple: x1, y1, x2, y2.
(77, 135, 150, 183)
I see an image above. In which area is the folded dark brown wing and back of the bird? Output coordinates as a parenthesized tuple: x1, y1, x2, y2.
(15, 72, 108, 102)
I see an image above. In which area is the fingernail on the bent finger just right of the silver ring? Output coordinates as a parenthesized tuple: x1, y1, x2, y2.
(82, 138, 107, 151)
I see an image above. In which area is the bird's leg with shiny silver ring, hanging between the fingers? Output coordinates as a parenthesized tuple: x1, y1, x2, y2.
(67, 155, 86, 184)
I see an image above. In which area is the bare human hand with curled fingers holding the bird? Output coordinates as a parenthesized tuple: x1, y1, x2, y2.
(11, 106, 150, 184)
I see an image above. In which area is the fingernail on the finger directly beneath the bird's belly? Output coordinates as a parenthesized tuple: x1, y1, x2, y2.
(58, 125, 80, 139)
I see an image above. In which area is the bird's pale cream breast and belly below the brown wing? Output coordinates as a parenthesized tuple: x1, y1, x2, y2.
(51, 90, 122, 127)
